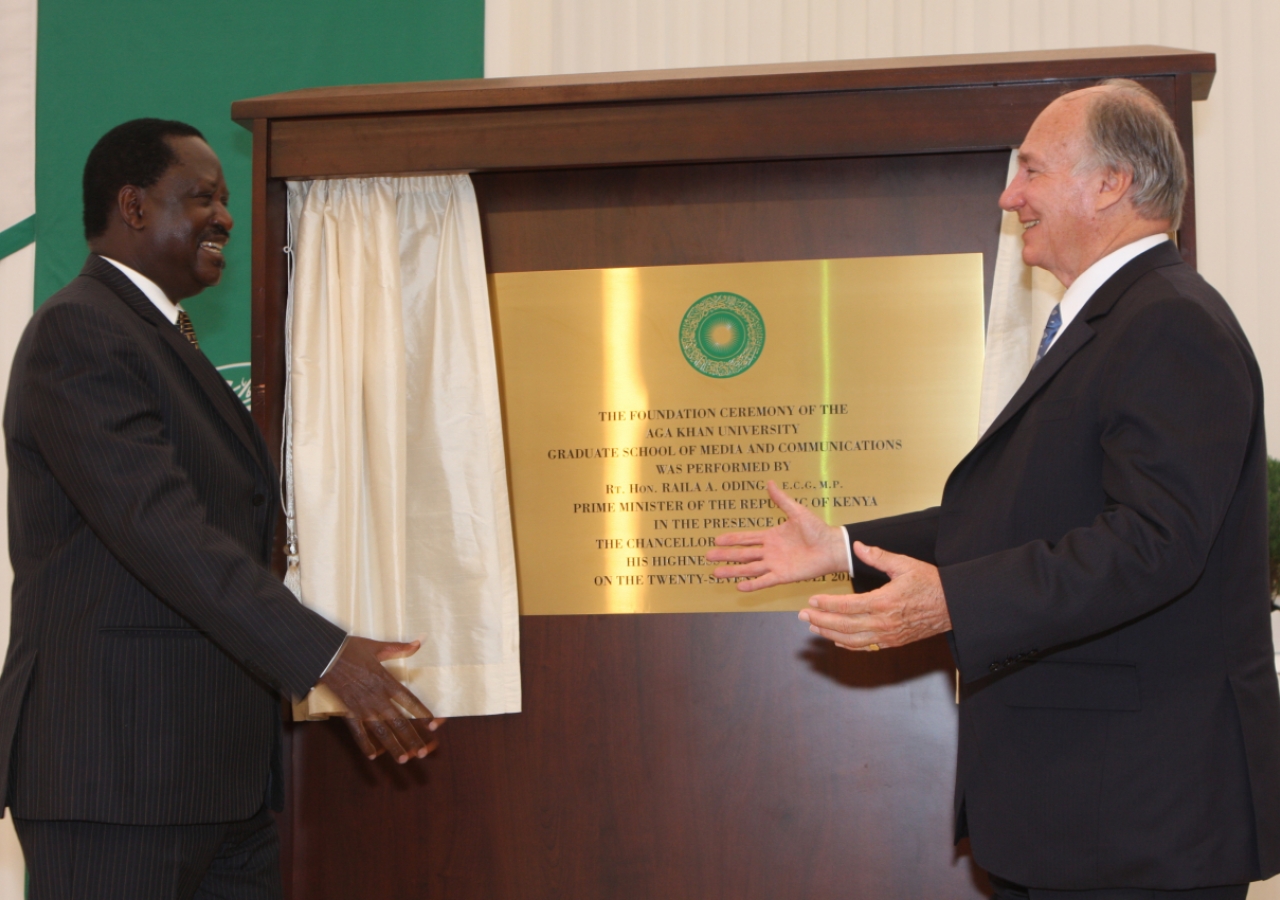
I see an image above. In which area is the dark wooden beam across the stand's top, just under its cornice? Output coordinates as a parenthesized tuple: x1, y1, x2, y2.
(270, 77, 1174, 178)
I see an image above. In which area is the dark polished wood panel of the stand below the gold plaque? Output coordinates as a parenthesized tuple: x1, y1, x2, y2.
(292, 613, 987, 900)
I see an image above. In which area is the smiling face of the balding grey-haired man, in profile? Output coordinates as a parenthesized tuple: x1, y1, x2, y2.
(1000, 91, 1106, 285)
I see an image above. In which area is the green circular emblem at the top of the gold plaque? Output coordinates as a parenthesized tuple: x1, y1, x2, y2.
(680, 291, 764, 378)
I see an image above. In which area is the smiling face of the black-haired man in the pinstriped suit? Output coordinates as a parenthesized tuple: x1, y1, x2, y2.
(131, 137, 234, 302)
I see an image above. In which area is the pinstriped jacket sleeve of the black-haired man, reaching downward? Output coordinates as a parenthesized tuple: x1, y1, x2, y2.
(15, 299, 344, 696)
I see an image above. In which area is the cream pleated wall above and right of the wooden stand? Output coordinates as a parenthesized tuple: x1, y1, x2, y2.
(485, 0, 1280, 900)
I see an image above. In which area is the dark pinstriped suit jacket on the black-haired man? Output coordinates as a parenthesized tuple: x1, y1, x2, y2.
(0, 256, 343, 824)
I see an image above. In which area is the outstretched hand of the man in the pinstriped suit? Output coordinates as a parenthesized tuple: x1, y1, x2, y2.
(320, 635, 444, 763)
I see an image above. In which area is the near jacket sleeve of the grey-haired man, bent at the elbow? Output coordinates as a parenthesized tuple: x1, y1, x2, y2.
(940, 296, 1258, 681)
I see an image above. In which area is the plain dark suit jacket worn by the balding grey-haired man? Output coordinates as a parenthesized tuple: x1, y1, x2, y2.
(849, 243, 1280, 890)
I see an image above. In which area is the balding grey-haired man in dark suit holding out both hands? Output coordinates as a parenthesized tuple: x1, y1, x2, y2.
(708, 82, 1280, 900)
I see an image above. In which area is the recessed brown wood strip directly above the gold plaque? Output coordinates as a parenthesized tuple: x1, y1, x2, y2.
(472, 150, 1009, 293)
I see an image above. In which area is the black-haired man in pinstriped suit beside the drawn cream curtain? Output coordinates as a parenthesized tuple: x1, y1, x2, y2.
(0, 119, 436, 900)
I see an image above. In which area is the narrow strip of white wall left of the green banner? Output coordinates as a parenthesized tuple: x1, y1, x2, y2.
(0, 0, 36, 885)
